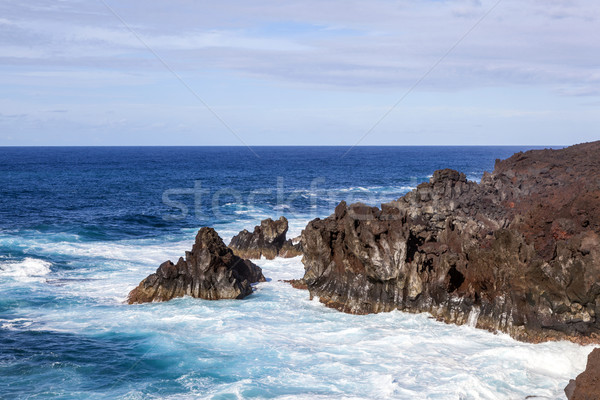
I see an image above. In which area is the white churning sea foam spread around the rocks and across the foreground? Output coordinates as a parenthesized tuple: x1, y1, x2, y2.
(0, 230, 591, 400)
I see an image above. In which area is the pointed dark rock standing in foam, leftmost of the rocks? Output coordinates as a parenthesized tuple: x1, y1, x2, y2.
(128, 228, 265, 304)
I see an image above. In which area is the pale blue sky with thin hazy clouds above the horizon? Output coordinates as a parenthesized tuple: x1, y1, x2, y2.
(0, 0, 600, 146)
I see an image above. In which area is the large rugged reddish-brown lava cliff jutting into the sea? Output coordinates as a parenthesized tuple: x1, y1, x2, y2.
(302, 142, 600, 342)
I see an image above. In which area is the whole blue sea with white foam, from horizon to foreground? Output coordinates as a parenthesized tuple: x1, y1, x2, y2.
(0, 147, 590, 399)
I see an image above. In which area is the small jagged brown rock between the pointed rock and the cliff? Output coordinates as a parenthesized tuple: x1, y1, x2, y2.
(229, 217, 302, 260)
